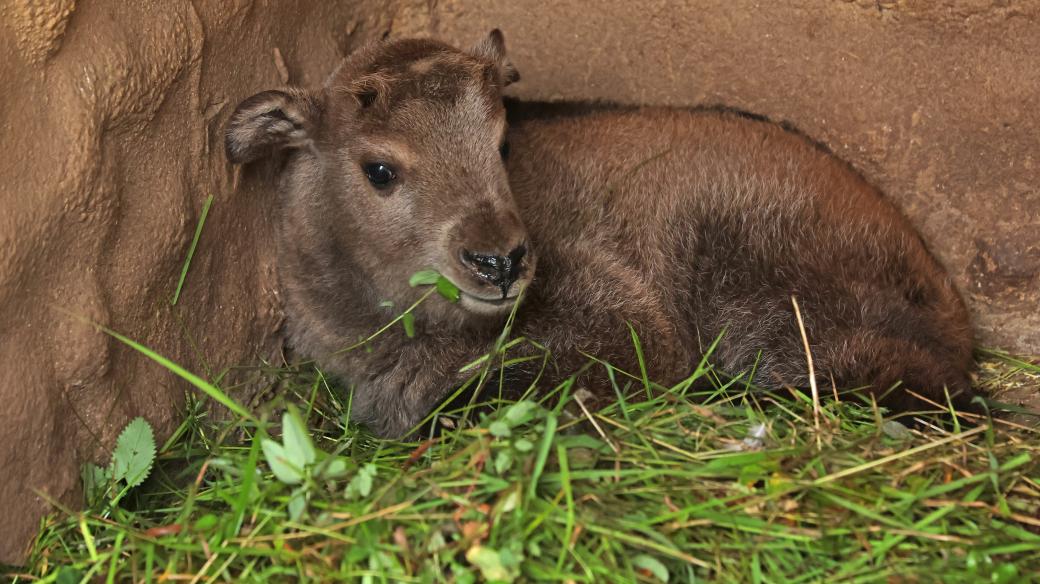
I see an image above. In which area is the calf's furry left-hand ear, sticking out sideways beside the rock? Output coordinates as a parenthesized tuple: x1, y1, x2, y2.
(224, 89, 319, 164)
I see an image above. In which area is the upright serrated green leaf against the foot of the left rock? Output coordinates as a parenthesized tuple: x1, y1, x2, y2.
(83, 418, 155, 504)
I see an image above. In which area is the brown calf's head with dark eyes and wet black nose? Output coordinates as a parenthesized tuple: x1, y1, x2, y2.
(226, 30, 536, 320)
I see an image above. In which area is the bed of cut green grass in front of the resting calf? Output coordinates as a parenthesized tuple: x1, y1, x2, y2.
(11, 317, 1040, 583)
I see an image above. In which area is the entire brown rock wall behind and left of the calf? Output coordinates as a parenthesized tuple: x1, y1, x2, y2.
(0, 0, 1040, 561)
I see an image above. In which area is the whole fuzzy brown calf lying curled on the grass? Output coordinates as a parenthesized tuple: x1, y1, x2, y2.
(226, 31, 971, 436)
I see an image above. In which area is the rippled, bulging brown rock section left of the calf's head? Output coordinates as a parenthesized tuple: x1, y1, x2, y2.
(0, 0, 390, 562)
